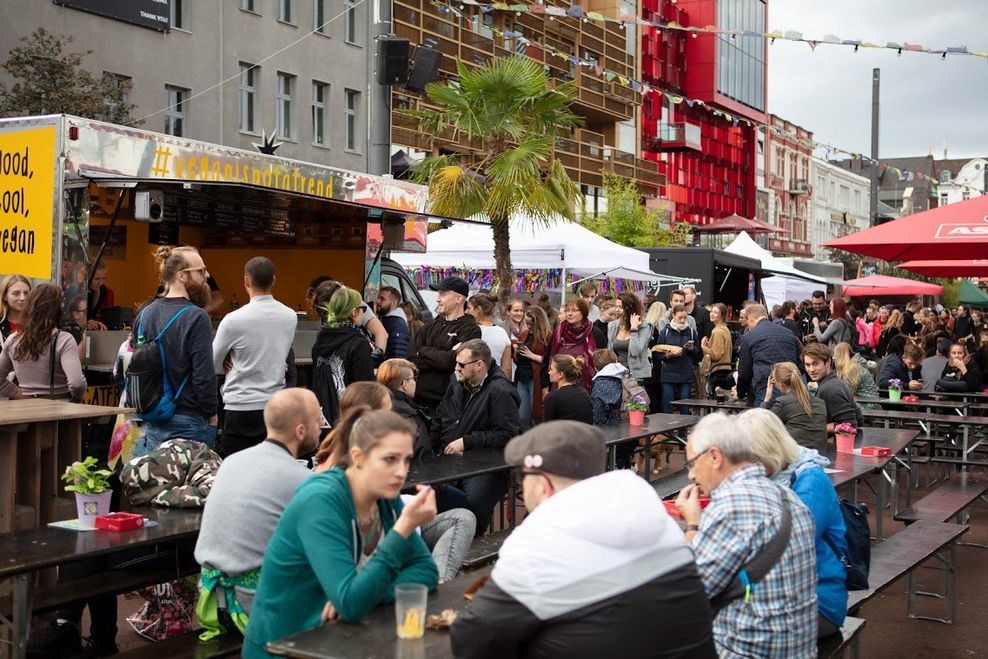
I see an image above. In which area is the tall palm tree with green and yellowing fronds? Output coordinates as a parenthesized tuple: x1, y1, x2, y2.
(406, 57, 582, 301)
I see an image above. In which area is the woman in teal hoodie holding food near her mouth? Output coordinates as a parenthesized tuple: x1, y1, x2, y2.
(243, 406, 439, 659)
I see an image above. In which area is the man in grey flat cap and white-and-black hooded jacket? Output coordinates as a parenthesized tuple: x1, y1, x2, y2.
(451, 421, 717, 659)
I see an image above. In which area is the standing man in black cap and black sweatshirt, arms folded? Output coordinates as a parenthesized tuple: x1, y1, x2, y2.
(408, 277, 480, 415)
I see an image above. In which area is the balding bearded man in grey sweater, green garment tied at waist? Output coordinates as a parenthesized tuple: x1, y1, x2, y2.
(195, 389, 322, 639)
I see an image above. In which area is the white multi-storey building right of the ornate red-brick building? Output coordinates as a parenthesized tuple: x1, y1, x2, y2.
(810, 158, 870, 261)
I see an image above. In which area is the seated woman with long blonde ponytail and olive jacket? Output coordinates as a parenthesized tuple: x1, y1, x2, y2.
(762, 362, 827, 450)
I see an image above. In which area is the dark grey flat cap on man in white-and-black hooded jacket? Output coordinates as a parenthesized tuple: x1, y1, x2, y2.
(504, 421, 607, 480)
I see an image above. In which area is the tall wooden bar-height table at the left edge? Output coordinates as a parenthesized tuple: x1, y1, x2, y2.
(0, 398, 130, 533)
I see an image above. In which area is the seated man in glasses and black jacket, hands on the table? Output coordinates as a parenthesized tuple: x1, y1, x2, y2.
(431, 339, 521, 535)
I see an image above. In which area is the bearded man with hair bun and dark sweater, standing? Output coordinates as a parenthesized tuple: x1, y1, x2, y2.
(131, 247, 218, 458)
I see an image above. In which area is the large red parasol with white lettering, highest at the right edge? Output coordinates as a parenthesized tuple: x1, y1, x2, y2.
(826, 195, 988, 261)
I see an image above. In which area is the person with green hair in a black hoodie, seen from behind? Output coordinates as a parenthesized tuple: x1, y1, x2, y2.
(312, 286, 374, 424)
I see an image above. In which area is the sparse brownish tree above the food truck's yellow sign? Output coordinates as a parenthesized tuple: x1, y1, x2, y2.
(0, 28, 135, 124)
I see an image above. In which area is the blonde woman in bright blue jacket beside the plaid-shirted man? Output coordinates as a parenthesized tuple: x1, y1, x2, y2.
(737, 408, 848, 638)
